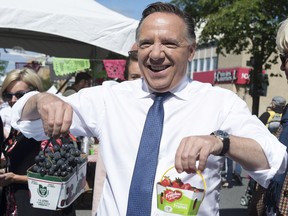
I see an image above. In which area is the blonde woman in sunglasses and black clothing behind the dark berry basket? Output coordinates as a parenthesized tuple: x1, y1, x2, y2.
(0, 68, 76, 216)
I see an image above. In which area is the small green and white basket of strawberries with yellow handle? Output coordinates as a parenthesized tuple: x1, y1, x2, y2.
(157, 166, 207, 216)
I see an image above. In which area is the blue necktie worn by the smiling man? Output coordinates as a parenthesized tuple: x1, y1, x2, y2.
(127, 92, 171, 216)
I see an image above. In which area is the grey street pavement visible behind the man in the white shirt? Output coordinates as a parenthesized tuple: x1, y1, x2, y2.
(76, 171, 249, 216)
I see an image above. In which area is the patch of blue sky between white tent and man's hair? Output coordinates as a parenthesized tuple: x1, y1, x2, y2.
(96, 0, 168, 20)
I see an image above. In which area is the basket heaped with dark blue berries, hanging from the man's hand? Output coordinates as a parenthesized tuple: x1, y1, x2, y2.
(27, 135, 87, 210)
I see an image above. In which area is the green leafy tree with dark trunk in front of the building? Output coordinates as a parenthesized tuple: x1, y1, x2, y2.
(171, 0, 288, 114)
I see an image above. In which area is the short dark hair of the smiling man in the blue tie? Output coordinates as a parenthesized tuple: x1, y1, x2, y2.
(136, 2, 196, 43)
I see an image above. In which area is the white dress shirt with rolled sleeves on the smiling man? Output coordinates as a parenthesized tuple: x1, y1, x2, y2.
(12, 78, 286, 216)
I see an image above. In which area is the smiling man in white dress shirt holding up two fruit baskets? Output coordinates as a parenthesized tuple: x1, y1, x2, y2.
(13, 2, 287, 216)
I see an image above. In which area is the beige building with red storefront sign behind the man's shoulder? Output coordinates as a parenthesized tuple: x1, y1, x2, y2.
(188, 45, 288, 116)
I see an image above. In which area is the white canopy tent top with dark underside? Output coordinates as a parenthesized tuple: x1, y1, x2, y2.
(0, 0, 139, 59)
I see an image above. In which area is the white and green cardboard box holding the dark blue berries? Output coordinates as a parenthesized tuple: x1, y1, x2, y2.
(27, 160, 87, 210)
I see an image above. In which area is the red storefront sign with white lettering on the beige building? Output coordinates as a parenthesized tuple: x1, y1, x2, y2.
(193, 67, 255, 85)
